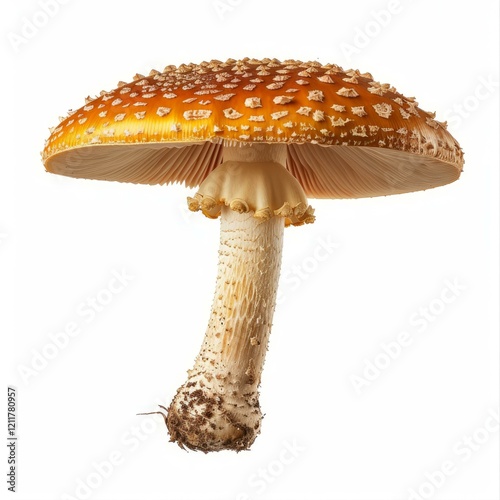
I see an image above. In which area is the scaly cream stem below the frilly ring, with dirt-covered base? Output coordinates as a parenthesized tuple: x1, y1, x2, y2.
(167, 206, 285, 452)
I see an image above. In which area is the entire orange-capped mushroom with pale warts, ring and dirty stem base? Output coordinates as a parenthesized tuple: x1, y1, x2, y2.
(43, 59, 463, 452)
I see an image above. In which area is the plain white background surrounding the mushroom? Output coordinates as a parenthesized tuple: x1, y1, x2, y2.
(0, 0, 499, 500)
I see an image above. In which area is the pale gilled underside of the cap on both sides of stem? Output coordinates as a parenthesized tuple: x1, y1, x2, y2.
(46, 141, 461, 198)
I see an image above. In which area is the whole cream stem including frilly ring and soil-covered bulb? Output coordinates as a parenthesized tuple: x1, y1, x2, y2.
(166, 144, 314, 452)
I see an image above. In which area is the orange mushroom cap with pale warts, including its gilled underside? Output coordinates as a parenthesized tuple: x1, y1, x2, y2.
(42, 59, 463, 198)
